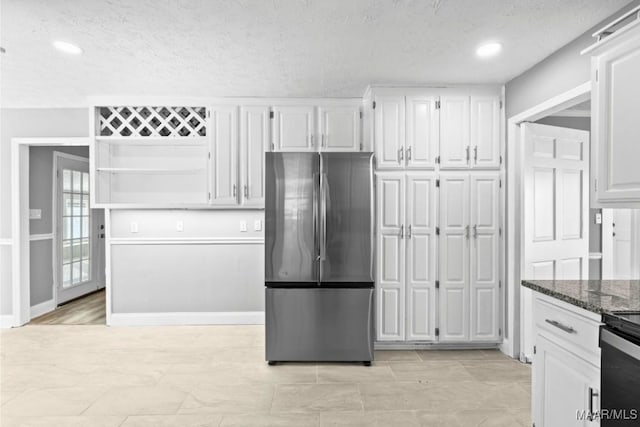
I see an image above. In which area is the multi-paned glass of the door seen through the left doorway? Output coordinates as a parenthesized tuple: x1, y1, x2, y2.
(62, 168, 91, 288)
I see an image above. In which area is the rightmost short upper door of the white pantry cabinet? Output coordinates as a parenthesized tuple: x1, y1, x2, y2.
(471, 96, 500, 168)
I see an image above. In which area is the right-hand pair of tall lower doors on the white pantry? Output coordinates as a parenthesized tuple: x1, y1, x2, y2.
(439, 172, 501, 342)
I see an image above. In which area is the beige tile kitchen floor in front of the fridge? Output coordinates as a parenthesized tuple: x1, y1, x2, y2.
(0, 326, 531, 427)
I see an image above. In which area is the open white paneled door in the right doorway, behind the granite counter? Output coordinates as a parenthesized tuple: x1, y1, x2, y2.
(521, 123, 589, 357)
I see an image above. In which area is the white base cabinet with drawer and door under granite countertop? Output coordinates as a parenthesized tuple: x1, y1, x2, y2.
(532, 293, 600, 427)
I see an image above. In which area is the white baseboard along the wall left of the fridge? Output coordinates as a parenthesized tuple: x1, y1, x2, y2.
(108, 311, 264, 326)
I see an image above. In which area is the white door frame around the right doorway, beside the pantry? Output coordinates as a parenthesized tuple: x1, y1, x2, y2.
(500, 81, 591, 361)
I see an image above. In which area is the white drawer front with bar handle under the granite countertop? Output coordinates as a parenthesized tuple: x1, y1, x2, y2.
(534, 298, 600, 366)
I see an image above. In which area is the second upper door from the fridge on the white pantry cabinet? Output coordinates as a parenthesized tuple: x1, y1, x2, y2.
(406, 96, 440, 169)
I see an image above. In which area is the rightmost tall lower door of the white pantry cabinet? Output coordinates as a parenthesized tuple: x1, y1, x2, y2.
(470, 172, 500, 341)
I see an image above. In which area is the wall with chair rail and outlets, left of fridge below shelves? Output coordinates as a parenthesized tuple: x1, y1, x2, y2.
(110, 210, 264, 314)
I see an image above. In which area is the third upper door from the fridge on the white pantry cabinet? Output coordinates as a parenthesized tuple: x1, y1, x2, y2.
(440, 96, 471, 169)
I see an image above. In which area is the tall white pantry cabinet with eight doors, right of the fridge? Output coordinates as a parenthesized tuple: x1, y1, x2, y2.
(364, 87, 502, 343)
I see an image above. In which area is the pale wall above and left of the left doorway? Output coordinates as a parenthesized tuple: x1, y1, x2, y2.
(0, 108, 89, 315)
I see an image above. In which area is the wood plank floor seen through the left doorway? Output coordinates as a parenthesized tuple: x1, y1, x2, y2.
(30, 289, 106, 325)
